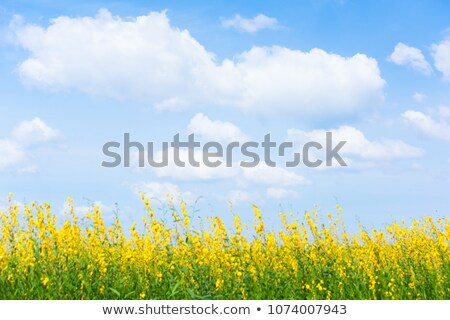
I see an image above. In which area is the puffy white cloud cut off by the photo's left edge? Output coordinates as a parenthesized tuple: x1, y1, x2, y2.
(0, 118, 59, 174)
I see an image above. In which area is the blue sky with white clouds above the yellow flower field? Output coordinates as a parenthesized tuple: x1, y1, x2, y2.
(0, 0, 450, 230)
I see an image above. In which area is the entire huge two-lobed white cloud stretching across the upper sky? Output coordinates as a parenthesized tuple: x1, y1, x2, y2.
(14, 9, 385, 116)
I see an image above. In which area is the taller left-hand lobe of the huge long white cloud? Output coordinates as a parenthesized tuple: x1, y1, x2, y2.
(16, 9, 213, 108)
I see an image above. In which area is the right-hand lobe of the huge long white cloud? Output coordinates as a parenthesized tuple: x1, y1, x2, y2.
(220, 46, 384, 116)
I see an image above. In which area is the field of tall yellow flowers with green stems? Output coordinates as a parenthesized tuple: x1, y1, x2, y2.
(0, 196, 450, 299)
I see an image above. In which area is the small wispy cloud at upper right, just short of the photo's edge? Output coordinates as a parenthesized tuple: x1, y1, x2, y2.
(390, 42, 432, 74)
